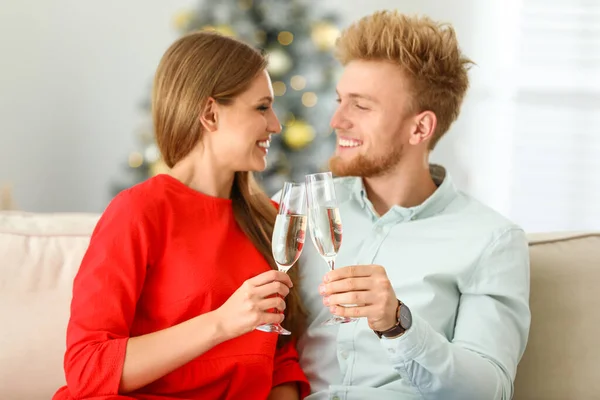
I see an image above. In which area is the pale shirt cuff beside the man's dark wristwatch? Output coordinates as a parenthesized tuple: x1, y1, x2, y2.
(380, 314, 429, 364)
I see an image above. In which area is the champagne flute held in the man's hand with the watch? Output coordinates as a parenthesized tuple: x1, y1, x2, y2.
(306, 172, 356, 325)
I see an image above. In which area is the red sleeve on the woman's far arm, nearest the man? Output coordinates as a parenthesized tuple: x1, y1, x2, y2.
(273, 339, 310, 399)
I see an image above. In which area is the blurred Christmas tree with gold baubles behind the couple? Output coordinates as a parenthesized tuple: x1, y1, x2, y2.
(113, 0, 339, 195)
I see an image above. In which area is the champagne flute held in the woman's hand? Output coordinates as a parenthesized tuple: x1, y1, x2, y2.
(256, 182, 307, 335)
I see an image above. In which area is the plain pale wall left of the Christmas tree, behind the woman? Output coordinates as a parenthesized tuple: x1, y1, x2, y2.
(0, 0, 193, 211)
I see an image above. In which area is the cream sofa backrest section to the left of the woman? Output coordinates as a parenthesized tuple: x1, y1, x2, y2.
(0, 212, 98, 400)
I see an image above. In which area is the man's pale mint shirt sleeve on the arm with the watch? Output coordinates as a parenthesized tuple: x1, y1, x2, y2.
(381, 228, 531, 400)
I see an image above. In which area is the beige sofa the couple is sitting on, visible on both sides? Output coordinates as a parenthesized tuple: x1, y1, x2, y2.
(0, 212, 600, 400)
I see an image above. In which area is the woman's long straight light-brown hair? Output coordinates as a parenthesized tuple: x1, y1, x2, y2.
(152, 32, 306, 344)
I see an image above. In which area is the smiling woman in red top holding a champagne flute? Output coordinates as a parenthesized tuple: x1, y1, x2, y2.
(54, 32, 309, 400)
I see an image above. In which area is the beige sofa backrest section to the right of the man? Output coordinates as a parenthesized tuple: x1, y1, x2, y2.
(514, 233, 600, 400)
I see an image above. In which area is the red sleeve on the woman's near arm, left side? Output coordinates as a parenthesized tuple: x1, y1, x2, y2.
(64, 192, 149, 398)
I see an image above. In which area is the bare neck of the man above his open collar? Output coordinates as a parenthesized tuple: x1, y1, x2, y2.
(363, 155, 437, 215)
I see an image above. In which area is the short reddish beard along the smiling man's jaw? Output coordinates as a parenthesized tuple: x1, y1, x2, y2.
(329, 143, 404, 178)
